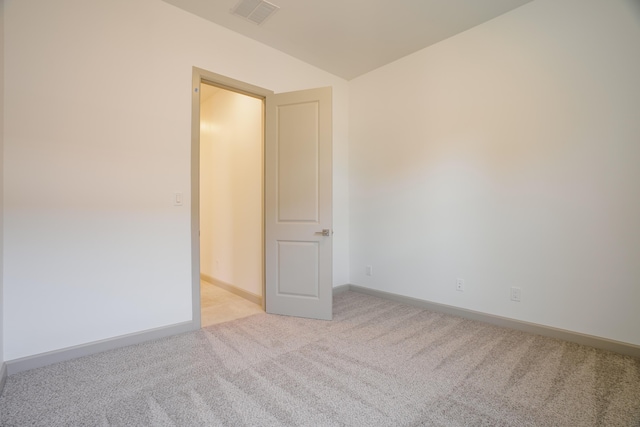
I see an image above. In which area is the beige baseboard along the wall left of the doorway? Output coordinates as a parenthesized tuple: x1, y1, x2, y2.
(3, 322, 199, 375)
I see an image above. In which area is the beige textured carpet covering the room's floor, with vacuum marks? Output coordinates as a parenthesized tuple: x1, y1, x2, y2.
(0, 292, 640, 426)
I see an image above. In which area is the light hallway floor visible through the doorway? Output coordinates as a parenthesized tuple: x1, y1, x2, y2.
(200, 281, 264, 327)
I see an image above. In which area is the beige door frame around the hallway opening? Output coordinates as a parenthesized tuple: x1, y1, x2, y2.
(191, 67, 273, 329)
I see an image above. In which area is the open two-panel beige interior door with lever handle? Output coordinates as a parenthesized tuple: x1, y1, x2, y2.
(265, 88, 333, 320)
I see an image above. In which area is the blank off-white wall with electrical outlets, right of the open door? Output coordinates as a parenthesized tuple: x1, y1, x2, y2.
(349, 0, 640, 344)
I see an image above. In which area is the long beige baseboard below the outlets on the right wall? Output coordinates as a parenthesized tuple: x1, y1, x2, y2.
(344, 285, 640, 359)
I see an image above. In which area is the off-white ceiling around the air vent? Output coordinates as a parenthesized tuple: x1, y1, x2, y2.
(163, 0, 532, 80)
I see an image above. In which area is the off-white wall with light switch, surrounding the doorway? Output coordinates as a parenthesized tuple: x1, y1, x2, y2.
(4, 0, 348, 360)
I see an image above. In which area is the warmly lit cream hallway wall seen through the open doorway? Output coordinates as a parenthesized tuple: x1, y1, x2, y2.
(200, 85, 264, 296)
